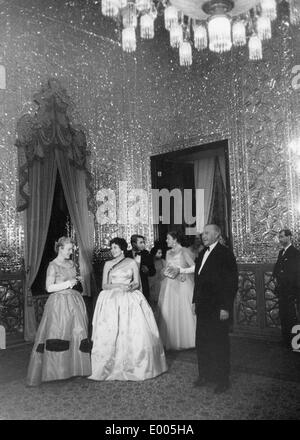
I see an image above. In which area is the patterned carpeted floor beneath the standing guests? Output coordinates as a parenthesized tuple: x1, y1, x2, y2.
(0, 337, 300, 420)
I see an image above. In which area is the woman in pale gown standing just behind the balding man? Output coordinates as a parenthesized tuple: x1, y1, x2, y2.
(158, 232, 196, 350)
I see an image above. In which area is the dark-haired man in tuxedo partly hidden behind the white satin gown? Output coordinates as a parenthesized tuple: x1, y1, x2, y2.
(126, 234, 156, 301)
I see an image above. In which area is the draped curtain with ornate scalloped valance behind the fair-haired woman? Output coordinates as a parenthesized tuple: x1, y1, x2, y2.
(16, 79, 95, 341)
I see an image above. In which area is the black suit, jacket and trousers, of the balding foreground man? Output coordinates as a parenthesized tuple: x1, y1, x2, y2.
(193, 243, 238, 384)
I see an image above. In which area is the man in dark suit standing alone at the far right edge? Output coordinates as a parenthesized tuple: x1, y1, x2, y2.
(273, 229, 300, 348)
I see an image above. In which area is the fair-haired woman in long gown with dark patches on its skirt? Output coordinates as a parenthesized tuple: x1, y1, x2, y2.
(27, 237, 91, 386)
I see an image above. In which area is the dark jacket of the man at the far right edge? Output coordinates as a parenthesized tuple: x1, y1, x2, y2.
(273, 245, 300, 297)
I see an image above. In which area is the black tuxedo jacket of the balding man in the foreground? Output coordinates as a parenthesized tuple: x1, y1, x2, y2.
(193, 243, 238, 321)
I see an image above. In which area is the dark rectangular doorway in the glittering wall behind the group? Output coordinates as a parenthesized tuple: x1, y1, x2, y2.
(151, 140, 232, 247)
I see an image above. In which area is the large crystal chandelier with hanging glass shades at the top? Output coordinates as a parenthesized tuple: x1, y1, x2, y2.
(102, 0, 300, 66)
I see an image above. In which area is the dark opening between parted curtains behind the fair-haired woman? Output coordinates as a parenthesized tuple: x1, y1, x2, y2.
(31, 171, 70, 295)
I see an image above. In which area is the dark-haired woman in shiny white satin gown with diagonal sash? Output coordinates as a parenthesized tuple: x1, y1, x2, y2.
(89, 237, 167, 381)
